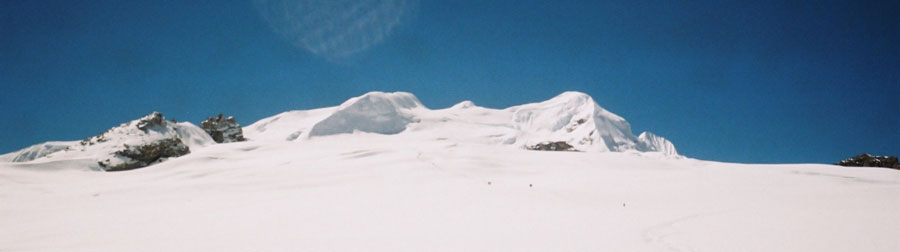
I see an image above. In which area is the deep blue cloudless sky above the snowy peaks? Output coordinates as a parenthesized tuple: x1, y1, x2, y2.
(0, 0, 900, 163)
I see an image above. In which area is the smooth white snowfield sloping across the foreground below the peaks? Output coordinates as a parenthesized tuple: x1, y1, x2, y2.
(0, 132, 900, 252)
